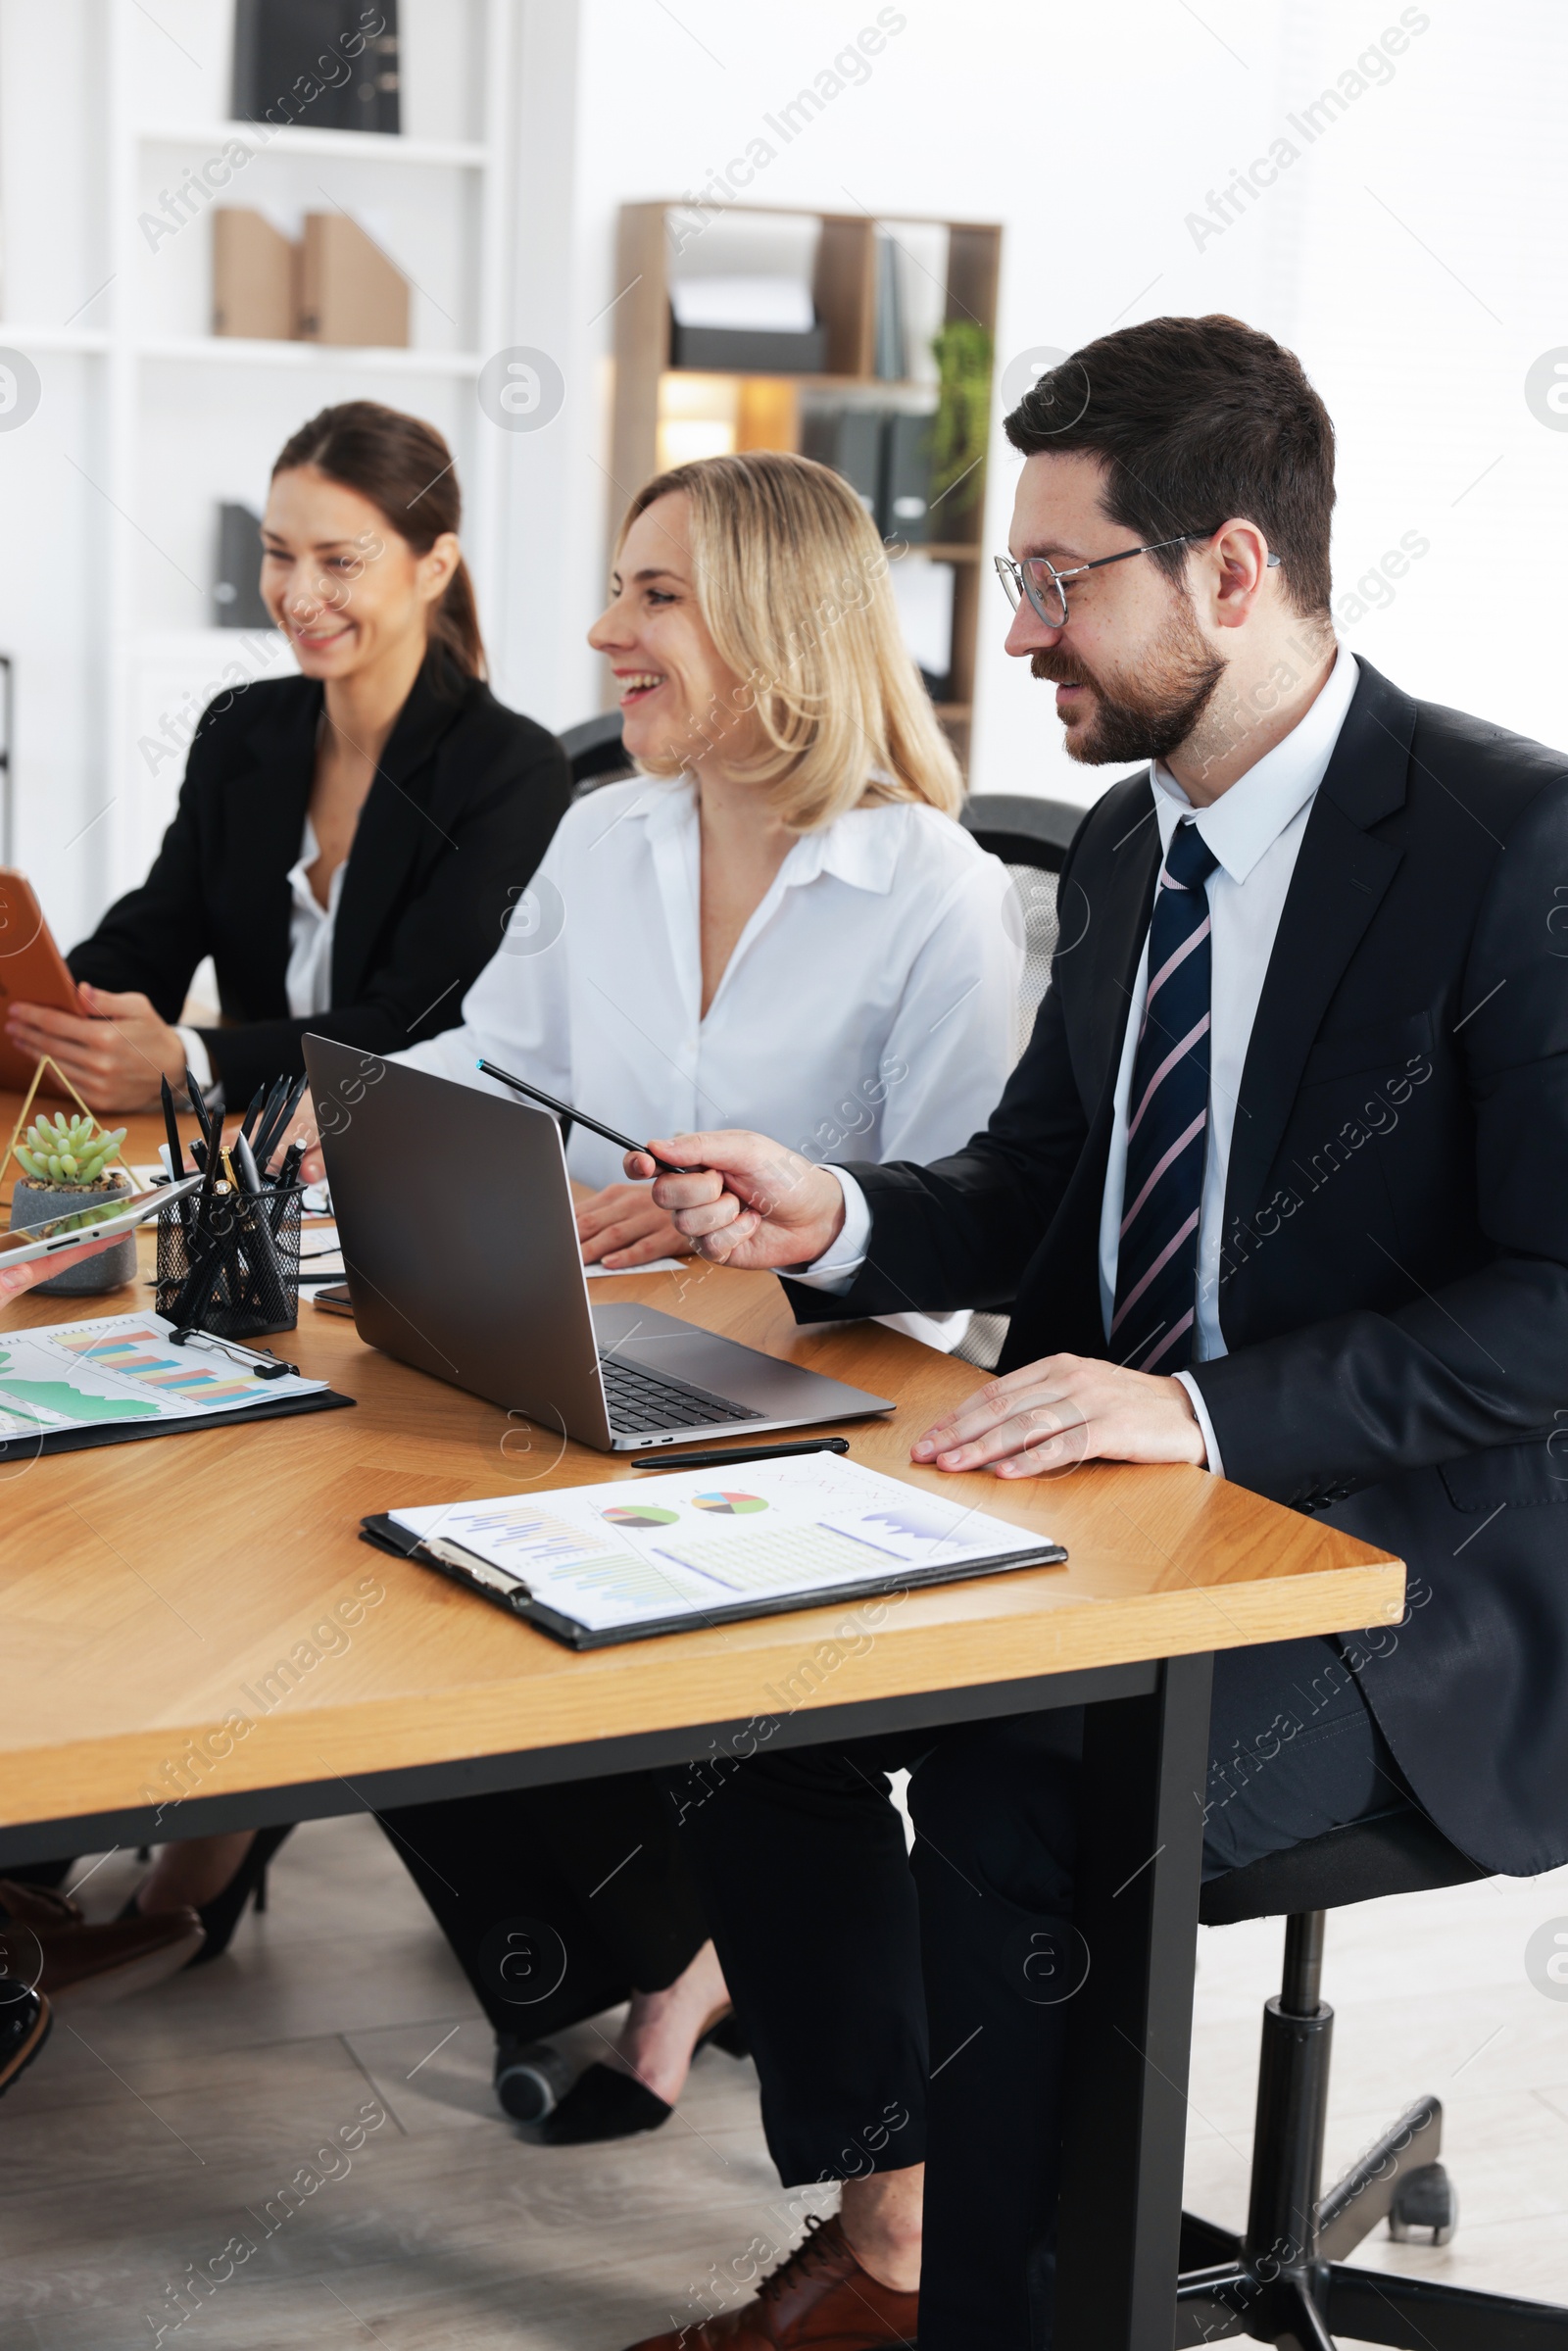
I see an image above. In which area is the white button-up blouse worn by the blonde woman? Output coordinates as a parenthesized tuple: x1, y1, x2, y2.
(393, 778, 1022, 1347)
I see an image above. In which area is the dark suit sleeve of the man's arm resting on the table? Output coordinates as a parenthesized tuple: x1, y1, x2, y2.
(1192, 778, 1568, 1502)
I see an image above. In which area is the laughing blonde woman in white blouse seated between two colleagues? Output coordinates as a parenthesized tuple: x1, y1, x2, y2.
(319, 452, 1020, 2141)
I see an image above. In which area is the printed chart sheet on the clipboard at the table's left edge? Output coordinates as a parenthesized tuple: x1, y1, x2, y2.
(0, 1314, 326, 1444)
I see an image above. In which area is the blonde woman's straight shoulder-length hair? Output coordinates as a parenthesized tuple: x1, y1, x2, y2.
(615, 449, 964, 832)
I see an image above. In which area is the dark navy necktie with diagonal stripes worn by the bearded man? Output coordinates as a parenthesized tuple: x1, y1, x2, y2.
(1109, 820, 1220, 1373)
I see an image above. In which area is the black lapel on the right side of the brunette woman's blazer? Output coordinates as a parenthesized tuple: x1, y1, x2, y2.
(331, 663, 477, 1004)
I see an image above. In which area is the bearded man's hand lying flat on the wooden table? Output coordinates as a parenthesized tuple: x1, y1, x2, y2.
(909, 1354, 1208, 1477)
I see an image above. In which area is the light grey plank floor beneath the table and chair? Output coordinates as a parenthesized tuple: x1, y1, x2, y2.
(0, 1820, 1568, 2351)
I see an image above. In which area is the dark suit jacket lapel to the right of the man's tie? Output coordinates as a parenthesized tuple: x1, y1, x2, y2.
(1225, 661, 1415, 1234)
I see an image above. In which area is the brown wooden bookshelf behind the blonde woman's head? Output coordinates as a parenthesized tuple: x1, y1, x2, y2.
(612, 200, 1002, 766)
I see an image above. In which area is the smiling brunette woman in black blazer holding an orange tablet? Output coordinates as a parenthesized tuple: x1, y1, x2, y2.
(7, 400, 569, 1109)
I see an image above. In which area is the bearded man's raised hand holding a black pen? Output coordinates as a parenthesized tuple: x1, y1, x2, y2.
(625, 1129, 844, 1272)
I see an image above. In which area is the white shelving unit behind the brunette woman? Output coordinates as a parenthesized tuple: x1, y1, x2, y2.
(0, 0, 526, 936)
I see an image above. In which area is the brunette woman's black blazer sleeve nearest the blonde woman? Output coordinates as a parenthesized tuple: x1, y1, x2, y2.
(190, 703, 571, 1107)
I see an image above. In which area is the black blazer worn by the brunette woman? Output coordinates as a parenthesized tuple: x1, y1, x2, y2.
(69, 656, 569, 1107)
